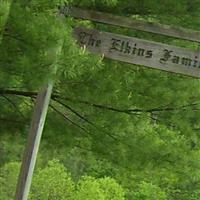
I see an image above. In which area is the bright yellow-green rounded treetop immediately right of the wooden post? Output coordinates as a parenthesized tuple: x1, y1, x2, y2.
(30, 161, 74, 200)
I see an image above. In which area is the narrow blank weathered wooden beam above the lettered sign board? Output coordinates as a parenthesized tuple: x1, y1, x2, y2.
(60, 7, 200, 42)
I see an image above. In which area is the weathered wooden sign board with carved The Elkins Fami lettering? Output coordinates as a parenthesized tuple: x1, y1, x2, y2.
(74, 27, 200, 77)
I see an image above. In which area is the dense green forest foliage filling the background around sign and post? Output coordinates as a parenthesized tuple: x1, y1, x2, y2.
(0, 0, 200, 200)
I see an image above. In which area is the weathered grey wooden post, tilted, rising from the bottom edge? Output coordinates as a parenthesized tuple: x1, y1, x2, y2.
(15, 83, 53, 200)
